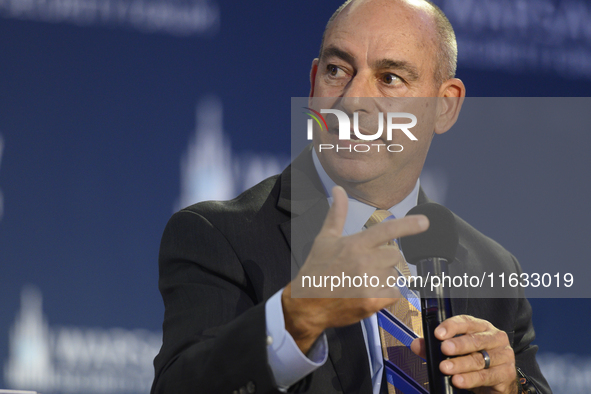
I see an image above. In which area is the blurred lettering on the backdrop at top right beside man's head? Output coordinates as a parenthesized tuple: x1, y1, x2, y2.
(435, 0, 591, 79)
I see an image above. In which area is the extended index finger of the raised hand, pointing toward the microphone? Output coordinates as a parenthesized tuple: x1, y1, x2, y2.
(351, 215, 429, 247)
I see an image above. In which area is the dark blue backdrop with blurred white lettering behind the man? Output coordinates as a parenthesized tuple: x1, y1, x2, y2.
(0, 0, 591, 393)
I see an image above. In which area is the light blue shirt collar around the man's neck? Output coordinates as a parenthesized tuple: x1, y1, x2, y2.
(312, 149, 420, 235)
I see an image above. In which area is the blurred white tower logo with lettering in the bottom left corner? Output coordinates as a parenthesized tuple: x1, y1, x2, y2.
(4, 285, 162, 394)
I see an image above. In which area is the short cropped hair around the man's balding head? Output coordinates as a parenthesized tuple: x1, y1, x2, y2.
(319, 0, 458, 86)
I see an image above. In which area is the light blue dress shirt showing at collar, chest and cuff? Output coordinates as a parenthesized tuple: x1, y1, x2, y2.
(265, 150, 420, 394)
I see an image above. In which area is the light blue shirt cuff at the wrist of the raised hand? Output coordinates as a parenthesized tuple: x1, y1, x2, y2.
(265, 289, 328, 391)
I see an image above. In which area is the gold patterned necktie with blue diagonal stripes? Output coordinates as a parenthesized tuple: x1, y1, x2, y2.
(364, 209, 429, 394)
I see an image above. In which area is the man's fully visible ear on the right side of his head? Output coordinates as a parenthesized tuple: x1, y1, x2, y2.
(435, 78, 466, 134)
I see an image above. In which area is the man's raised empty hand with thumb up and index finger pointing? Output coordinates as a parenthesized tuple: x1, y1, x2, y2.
(282, 186, 429, 354)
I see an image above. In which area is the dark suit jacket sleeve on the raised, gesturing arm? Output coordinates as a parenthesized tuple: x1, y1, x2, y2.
(152, 210, 278, 394)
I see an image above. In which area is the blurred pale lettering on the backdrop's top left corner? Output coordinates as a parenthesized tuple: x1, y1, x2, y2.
(0, 0, 220, 36)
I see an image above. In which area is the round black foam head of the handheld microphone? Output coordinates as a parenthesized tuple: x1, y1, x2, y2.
(400, 203, 458, 264)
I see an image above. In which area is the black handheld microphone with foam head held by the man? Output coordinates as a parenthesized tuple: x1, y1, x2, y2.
(400, 203, 458, 394)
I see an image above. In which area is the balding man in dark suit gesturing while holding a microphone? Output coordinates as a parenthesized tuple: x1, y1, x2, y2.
(152, 0, 549, 394)
